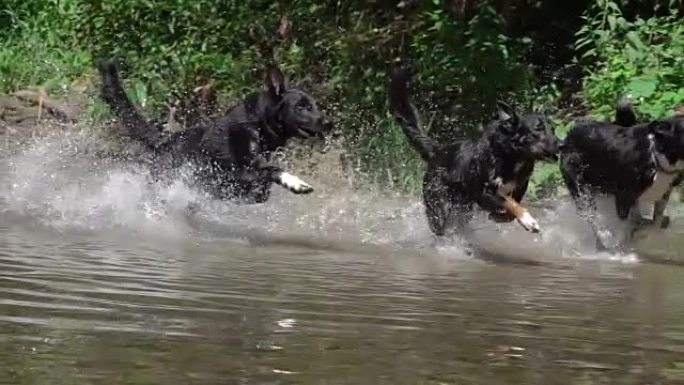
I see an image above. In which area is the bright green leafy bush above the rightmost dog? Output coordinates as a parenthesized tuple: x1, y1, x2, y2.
(577, 0, 684, 118)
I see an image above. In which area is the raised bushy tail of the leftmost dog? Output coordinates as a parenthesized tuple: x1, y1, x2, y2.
(97, 60, 162, 148)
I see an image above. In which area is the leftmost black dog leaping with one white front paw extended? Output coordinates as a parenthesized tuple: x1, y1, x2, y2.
(98, 61, 330, 203)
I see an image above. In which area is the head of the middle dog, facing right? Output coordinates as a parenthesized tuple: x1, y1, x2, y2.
(497, 101, 560, 161)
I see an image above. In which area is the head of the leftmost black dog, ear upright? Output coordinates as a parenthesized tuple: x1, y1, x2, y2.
(266, 67, 332, 138)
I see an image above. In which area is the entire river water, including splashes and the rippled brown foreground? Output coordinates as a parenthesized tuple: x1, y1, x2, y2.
(0, 131, 684, 384)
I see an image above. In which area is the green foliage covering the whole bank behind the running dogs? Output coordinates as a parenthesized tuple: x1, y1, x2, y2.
(0, 0, 684, 198)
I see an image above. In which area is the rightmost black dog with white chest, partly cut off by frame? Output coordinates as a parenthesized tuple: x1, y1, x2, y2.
(561, 103, 684, 251)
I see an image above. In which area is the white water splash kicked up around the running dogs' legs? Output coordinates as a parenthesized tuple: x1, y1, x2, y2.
(0, 133, 648, 262)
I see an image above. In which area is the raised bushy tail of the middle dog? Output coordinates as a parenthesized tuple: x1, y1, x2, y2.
(388, 68, 437, 162)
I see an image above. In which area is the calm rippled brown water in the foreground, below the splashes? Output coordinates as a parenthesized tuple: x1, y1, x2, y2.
(0, 222, 684, 384)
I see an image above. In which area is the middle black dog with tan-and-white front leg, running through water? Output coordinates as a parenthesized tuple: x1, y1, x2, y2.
(389, 69, 559, 235)
